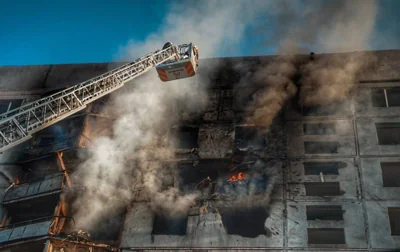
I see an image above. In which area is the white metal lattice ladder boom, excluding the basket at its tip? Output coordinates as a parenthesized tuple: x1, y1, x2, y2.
(0, 46, 181, 152)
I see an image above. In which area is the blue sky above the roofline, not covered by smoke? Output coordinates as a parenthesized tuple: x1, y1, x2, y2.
(0, 0, 400, 66)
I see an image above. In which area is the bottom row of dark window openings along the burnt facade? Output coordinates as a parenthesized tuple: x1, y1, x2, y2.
(147, 205, 400, 244)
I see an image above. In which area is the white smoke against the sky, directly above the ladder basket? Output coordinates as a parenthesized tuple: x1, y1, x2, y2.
(115, 0, 273, 59)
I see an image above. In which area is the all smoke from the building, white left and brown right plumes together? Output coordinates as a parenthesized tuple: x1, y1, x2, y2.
(69, 0, 384, 232)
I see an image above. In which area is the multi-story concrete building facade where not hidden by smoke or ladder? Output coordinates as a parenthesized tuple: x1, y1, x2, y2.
(0, 51, 400, 252)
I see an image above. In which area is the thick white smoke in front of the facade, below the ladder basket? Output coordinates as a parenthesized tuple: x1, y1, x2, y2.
(70, 73, 206, 229)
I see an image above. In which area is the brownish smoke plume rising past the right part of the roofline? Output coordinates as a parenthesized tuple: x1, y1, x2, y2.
(248, 0, 378, 125)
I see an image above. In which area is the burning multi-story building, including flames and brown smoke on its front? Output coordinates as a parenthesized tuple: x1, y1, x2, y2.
(0, 48, 400, 252)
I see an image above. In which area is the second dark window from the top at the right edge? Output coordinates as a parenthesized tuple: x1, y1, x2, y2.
(375, 123, 400, 145)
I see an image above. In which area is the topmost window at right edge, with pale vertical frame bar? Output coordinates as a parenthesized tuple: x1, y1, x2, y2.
(371, 87, 400, 108)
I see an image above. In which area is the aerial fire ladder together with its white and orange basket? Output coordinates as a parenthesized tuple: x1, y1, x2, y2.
(0, 42, 198, 153)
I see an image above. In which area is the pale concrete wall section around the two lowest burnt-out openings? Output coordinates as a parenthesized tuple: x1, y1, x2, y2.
(121, 199, 284, 248)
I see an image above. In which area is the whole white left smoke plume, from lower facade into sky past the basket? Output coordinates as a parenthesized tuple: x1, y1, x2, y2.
(69, 1, 276, 230)
